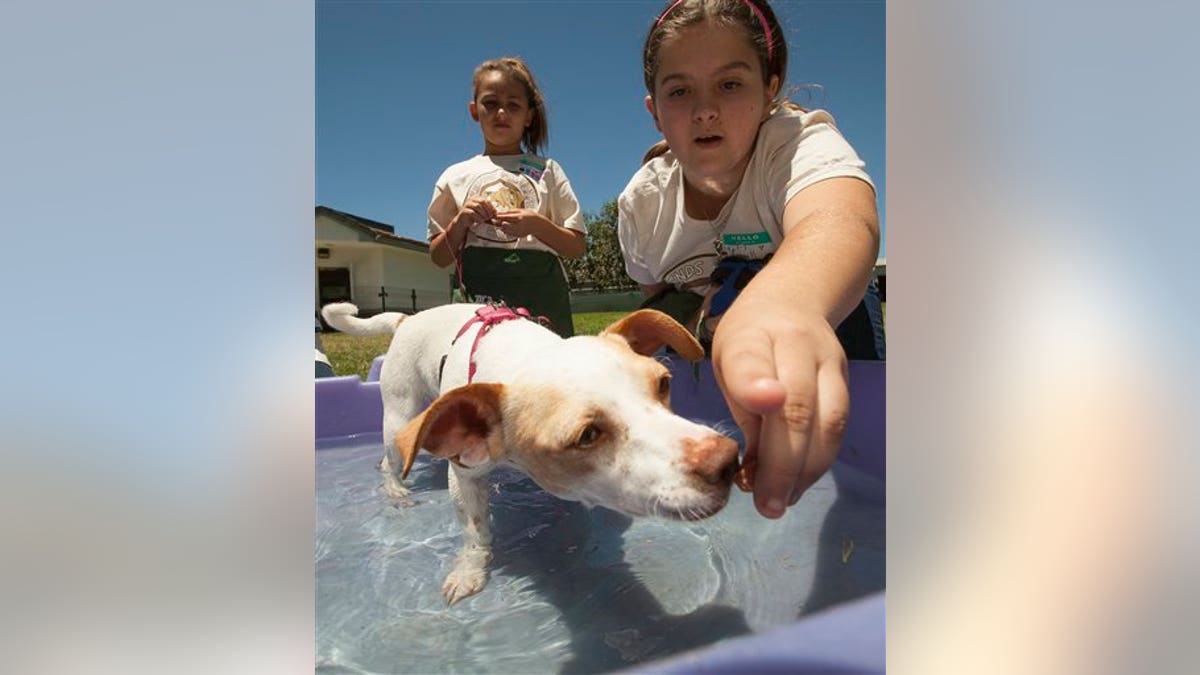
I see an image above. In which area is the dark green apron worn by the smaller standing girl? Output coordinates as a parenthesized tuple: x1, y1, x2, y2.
(462, 246, 575, 338)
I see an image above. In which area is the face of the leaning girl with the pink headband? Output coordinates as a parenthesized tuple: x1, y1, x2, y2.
(646, 22, 779, 190)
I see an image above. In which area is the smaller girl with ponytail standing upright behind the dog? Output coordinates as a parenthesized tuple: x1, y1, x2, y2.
(428, 58, 584, 338)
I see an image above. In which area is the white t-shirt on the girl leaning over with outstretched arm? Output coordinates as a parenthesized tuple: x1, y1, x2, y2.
(617, 108, 874, 294)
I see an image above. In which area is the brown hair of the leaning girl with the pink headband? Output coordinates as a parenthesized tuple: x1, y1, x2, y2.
(642, 0, 794, 165)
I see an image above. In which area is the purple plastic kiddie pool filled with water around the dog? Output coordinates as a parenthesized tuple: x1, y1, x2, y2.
(316, 357, 886, 674)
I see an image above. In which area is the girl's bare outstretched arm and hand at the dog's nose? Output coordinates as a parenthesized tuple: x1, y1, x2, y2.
(713, 178, 880, 518)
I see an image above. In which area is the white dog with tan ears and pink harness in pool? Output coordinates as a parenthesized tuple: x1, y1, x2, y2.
(322, 303, 738, 604)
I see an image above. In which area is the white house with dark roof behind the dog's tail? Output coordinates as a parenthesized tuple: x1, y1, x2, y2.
(316, 207, 454, 316)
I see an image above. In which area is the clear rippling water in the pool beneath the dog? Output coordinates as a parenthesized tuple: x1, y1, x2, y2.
(316, 436, 884, 673)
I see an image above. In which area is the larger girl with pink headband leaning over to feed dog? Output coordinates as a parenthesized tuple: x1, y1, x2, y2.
(618, 0, 882, 518)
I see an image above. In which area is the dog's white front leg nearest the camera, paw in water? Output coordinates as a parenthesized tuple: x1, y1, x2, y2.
(442, 464, 492, 604)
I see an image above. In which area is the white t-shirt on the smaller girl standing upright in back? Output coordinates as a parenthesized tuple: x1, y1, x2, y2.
(428, 154, 587, 255)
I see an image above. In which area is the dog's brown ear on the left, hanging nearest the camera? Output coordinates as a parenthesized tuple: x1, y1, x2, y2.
(396, 383, 504, 478)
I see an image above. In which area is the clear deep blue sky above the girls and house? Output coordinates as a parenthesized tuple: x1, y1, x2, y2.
(316, 0, 886, 255)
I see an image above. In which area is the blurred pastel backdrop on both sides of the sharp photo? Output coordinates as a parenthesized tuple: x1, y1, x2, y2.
(0, 0, 1200, 673)
